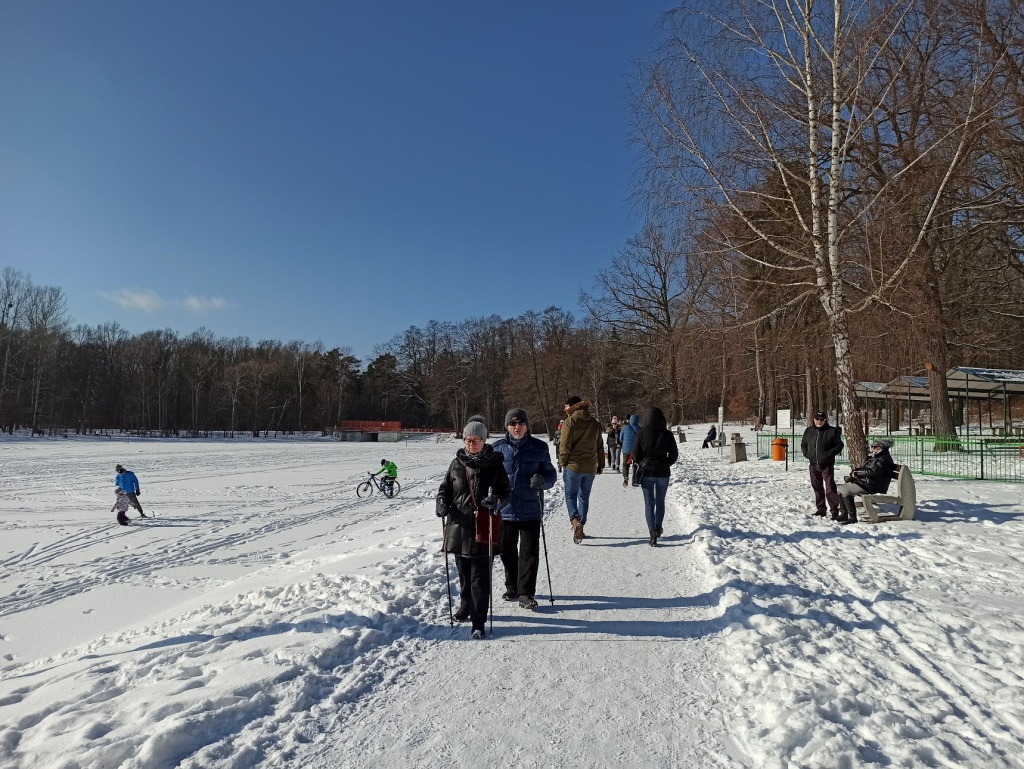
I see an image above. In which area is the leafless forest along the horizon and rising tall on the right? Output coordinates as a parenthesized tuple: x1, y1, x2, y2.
(0, 0, 1024, 462)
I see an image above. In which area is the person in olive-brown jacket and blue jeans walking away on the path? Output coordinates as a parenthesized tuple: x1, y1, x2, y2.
(558, 395, 604, 545)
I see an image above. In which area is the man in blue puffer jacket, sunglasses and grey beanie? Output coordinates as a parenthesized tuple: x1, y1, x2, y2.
(495, 409, 558, 610)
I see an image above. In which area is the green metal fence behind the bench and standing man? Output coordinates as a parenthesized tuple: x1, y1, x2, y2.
(758, 433, 1024, 483)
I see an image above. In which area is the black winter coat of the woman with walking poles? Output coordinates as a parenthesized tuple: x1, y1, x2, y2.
(437, 443, 512, 556)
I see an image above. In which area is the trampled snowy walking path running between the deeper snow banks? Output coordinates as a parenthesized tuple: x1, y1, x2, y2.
(301, 473, 727, 769)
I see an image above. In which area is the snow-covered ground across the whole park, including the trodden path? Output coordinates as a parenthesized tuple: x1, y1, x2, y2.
(0, 425, 1024, 769)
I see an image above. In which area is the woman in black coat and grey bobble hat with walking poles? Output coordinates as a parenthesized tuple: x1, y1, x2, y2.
(436, 421, 511, 639)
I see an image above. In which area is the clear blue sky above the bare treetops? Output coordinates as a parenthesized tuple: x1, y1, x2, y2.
(0, 0, 672, 358)
